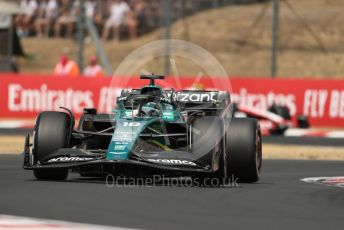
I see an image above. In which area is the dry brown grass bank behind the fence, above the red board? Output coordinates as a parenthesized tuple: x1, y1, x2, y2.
(20, 0, 344, 79)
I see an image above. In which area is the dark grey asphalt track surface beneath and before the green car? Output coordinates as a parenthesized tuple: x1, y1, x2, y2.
(0, 155, 344, 230)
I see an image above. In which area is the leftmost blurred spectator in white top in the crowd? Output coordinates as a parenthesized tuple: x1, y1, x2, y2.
(15, 0, 38, 36)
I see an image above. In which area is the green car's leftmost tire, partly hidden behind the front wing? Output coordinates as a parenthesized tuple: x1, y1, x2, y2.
(32, 112, 71, 180)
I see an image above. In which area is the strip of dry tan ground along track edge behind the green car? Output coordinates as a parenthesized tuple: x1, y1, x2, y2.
(0, 136, 344, 160)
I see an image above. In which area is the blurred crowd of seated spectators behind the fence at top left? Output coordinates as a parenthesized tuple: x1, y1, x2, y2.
(15, 0, 200, 40)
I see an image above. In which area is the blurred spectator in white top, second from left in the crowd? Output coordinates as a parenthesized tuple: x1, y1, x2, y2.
(35, 0, 58, 37)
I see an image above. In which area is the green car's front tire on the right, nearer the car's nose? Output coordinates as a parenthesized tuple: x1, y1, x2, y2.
(191, 116, 226, 187)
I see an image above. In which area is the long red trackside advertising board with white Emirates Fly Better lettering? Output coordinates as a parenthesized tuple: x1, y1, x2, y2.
(0, 74, 344, 127)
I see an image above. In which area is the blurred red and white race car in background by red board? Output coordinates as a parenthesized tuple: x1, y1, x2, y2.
(233, 104, 310, 135)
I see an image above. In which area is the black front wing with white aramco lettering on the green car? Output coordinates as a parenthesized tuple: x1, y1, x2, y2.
(23, 137, 213, 174)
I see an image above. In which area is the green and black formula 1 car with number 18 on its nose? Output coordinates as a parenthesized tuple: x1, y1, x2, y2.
(24, 75, 262, 183)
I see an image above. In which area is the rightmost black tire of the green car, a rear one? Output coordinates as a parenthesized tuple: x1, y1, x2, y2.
(226, 118, 262, 183)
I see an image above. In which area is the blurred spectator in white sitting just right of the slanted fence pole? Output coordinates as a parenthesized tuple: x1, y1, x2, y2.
(103, 0, 130, 41)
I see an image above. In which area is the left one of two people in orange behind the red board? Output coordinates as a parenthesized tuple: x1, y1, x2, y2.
(54, 53, 80, 77)
